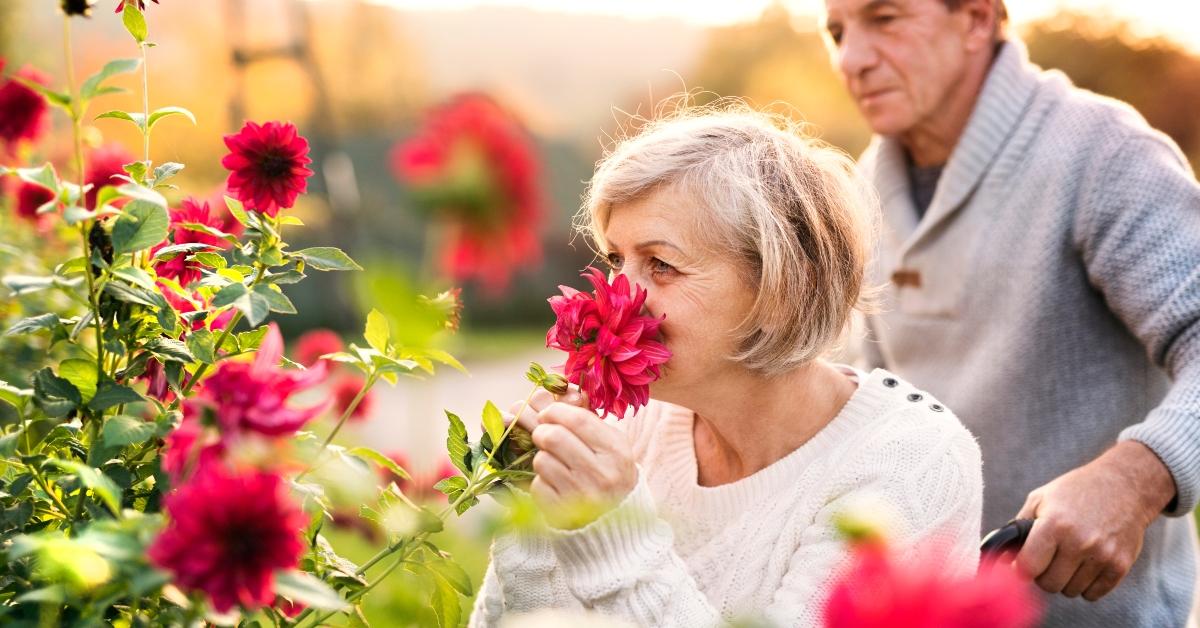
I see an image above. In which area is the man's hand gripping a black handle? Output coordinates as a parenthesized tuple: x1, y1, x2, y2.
(1016, 441, 1176, 602)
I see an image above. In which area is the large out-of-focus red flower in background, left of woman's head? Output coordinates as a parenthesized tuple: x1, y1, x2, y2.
(391, 94, 542, 294)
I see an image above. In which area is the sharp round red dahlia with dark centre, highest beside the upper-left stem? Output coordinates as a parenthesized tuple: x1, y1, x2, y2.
(221, 122, 312, 216)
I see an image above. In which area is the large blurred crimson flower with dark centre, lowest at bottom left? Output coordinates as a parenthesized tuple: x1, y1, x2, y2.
(149, 467, 307, 612)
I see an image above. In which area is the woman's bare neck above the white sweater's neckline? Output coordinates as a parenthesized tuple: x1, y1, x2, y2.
(692, 361, 856, 486)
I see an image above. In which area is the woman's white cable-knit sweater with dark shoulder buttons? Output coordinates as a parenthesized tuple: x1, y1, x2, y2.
(470, 370, 983, 627)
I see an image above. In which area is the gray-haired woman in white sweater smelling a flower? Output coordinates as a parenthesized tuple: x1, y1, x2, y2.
(472, 108, 982, 627)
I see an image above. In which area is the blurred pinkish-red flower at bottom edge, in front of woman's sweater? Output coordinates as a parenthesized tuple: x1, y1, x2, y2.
(824, 540, 1039, 628)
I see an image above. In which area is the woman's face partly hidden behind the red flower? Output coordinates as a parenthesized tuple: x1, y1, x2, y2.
(605, 189, 754, 406)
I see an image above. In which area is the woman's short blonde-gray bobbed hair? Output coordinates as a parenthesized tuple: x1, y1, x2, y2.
(576, 101, 878, 375)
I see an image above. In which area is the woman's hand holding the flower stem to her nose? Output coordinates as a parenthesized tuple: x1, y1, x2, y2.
(512, 389, 637, 528)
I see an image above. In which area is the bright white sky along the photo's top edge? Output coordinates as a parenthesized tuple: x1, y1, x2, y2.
(372, 0, 1200, 52)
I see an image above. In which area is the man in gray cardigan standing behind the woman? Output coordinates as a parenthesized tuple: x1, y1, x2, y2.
(826, 0, 1200, 628)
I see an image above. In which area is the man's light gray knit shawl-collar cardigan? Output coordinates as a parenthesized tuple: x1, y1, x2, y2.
(860, 42, 1200, 628)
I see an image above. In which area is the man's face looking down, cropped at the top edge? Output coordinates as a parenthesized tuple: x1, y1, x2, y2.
(826, 0, 970, 136)
